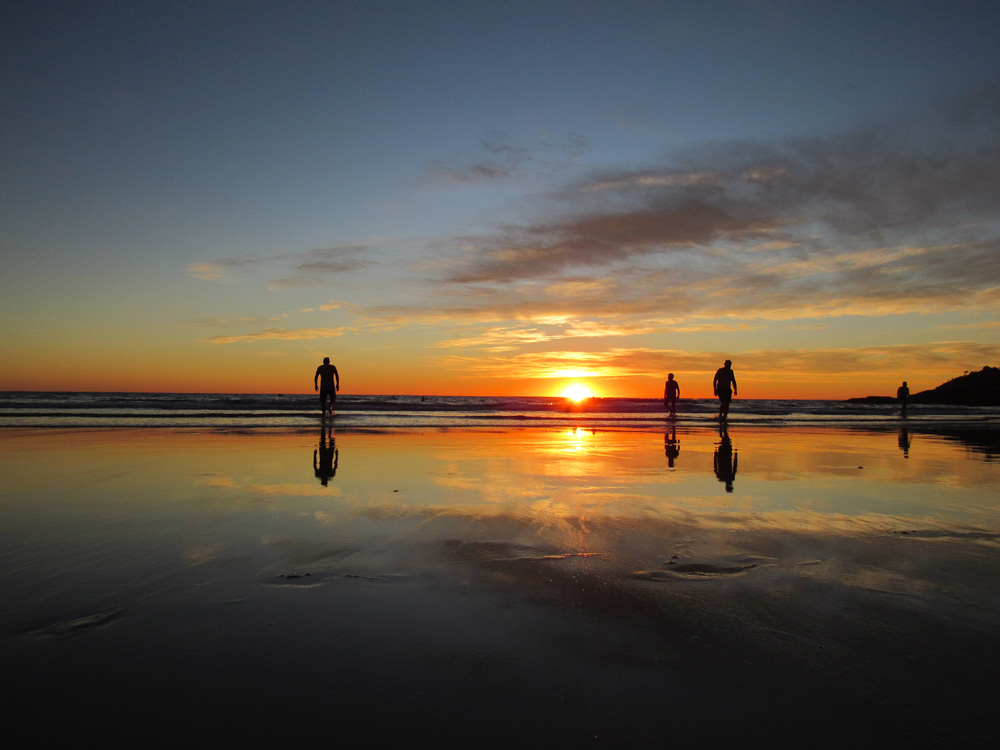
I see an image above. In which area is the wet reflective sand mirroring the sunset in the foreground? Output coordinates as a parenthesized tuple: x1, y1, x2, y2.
(0, 426, 1000, 747)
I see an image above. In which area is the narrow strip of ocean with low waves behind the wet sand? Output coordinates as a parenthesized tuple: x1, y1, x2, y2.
(0, 391, 1000, 430)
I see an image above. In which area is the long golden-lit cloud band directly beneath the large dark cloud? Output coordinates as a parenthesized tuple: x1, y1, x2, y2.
(364, 242, 1000, 338)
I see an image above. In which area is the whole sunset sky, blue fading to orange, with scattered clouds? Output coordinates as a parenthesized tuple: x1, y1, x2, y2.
(0, 0, 1000, 398)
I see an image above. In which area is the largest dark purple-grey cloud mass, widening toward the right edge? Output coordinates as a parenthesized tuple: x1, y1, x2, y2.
(440, 86, 1000, 317)
